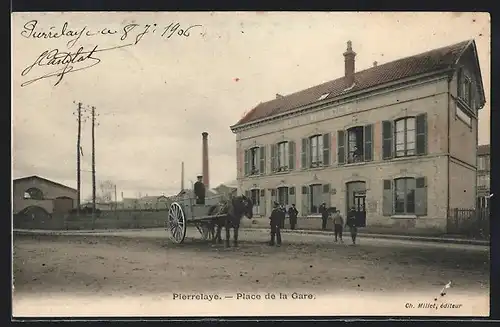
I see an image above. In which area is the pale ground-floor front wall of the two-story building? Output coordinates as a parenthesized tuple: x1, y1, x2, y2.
(242, 156, 447, 230)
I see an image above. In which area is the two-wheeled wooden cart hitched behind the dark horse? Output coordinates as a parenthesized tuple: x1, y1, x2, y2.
(165, 198, 225, 244)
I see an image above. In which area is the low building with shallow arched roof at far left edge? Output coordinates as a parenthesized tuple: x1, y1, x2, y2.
(12, 176, 78, 214)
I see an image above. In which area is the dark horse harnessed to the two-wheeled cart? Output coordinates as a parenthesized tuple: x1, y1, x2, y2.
(208, 195, 253, 247)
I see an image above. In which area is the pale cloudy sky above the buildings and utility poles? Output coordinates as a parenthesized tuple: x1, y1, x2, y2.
(12, 12, 490, 200)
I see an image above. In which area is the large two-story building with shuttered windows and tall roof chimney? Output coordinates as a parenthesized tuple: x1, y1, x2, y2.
(231, 40, 485, 230)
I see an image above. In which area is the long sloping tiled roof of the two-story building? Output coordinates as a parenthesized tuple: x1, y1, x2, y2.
(232, 40, 474, 128)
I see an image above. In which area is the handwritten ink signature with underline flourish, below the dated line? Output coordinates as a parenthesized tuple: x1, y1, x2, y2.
(21, 43, 133, 87)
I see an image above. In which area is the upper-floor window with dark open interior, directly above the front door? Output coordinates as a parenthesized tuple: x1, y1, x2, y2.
(337, 124, 373, 164)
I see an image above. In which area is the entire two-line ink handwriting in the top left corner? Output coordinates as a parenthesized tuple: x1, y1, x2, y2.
(21, 20, 202, 87)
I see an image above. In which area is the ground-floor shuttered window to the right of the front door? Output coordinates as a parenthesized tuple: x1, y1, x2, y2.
(382, 177, 427, 216)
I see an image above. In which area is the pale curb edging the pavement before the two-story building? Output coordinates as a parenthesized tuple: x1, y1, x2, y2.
(243, 227, 490, 246)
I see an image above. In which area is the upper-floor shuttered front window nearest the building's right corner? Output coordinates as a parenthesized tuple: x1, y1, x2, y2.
(382, 114, 427, 160)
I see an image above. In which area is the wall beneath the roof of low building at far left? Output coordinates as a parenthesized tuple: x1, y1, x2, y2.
(12, 179, 77, 213)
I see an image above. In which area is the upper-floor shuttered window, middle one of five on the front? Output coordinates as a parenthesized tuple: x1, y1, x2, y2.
(301, 133, 331, 169)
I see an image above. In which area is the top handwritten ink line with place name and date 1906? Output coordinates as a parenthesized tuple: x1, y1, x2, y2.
(21, 19, 202, 48)
